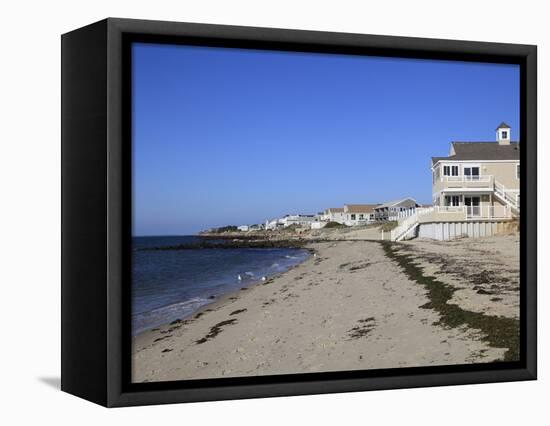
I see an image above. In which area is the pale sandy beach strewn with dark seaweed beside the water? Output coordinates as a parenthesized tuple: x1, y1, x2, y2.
(132, 236, 519, 382)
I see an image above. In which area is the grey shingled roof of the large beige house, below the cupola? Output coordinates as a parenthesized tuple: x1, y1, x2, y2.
(432, 142, 519, 164)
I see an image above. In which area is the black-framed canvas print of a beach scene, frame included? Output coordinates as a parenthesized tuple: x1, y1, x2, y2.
(62, 19, 537, 406)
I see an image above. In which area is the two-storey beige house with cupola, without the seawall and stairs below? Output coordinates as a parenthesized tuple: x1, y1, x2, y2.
(431, 123, 520, 220)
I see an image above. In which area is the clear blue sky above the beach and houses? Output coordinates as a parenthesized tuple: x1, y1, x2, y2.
(132, 44, 519, 235)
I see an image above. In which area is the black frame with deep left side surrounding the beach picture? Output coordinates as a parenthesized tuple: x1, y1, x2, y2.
(61, 18, 537, 407)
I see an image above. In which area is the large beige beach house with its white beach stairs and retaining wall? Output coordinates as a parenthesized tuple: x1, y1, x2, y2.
(386, 123, 520, 241)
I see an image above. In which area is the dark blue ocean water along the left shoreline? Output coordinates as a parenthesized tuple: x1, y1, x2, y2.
(132, 236, 309, 335)
